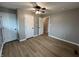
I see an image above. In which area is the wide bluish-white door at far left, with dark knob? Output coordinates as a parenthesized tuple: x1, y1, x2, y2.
(3, 13, 17, 42)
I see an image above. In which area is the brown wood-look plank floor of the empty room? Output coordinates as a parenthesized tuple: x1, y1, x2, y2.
(3, 35, 79, 57)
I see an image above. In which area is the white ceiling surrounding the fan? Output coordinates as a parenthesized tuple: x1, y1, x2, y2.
(0, 2, 79, 14)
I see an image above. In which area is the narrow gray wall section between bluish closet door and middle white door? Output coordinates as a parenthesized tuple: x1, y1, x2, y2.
(17, 9, 25, 39)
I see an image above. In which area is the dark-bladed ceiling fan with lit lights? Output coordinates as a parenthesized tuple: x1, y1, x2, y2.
(31, 2, 46, 14)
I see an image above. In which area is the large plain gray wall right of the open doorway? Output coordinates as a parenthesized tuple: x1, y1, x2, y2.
(49, 9, 79, 43)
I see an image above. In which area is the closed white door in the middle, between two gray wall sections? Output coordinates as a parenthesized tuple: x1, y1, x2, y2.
(25, 15, 34, 38)
